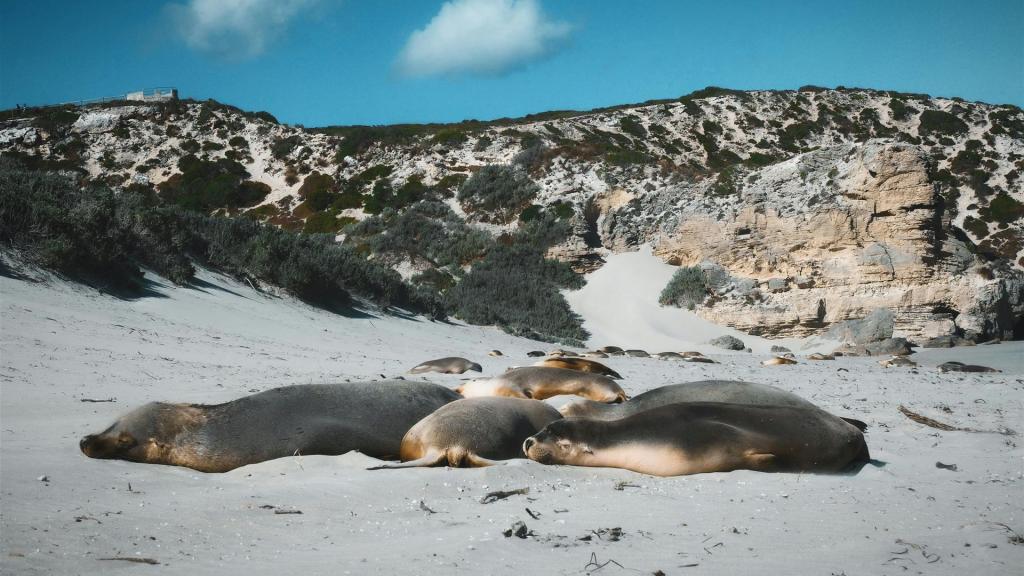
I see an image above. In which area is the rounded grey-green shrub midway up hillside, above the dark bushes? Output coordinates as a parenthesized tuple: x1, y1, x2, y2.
(457, 164, 540, 223)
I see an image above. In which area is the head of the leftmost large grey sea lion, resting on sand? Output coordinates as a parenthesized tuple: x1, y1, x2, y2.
(79, 402, 199, 463)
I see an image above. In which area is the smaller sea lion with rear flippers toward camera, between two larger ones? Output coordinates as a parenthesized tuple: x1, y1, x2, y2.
(370, 398, 562, 469)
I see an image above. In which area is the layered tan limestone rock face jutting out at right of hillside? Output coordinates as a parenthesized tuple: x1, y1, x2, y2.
(605, 140, 1024, 344)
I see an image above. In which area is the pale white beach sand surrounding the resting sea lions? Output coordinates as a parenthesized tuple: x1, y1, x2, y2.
(0, 271, 1024, 576)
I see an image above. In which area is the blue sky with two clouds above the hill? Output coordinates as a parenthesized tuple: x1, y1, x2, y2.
(0, 0, 1024, 126)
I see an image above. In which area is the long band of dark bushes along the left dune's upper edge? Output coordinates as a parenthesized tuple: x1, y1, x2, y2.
(0, 158, 439, 312)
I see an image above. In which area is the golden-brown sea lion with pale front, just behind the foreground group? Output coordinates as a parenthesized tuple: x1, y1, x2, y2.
(456, 366, 627, 403)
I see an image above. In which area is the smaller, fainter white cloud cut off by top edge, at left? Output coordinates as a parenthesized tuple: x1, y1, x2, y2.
(168, 0, 317, 58)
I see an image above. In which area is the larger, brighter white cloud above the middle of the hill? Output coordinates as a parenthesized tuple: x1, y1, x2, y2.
(397, 0, 571, 76)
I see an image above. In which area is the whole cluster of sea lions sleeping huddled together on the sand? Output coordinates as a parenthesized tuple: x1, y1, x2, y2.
(80, 346, 884, 476)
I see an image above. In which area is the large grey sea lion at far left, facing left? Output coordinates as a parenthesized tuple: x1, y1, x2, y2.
(79, 380, 460, 472)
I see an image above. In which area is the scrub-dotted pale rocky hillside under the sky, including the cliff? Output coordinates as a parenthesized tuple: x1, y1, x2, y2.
(0, 87, 1024, 340)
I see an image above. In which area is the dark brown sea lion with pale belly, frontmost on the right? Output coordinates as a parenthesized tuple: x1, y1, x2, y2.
(522, 402, 870, 476)
